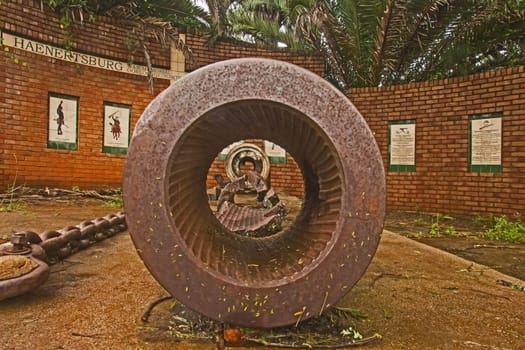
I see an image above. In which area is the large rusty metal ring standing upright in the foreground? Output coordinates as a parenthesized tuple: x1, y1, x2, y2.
(123, 59, 385, 327)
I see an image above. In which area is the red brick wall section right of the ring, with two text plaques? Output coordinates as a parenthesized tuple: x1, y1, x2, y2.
(350, 67, 525, 215)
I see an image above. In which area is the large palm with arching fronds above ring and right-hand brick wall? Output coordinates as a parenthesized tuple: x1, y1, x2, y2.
(225, 0, 525, 91)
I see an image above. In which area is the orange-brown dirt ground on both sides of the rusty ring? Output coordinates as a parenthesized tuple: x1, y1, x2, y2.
(0, 200, 525, 349)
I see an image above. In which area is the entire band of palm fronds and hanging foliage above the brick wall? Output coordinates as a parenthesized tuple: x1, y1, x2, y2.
(42, 0, 525, 91)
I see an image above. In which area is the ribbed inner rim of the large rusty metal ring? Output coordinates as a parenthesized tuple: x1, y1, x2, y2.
(165, 100, 342, 287)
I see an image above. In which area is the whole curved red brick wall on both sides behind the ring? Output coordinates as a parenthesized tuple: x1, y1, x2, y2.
(0, 0, 525, 215)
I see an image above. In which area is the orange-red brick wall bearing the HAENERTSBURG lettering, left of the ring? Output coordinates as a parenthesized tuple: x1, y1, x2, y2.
(0, 0, 324, 195)
